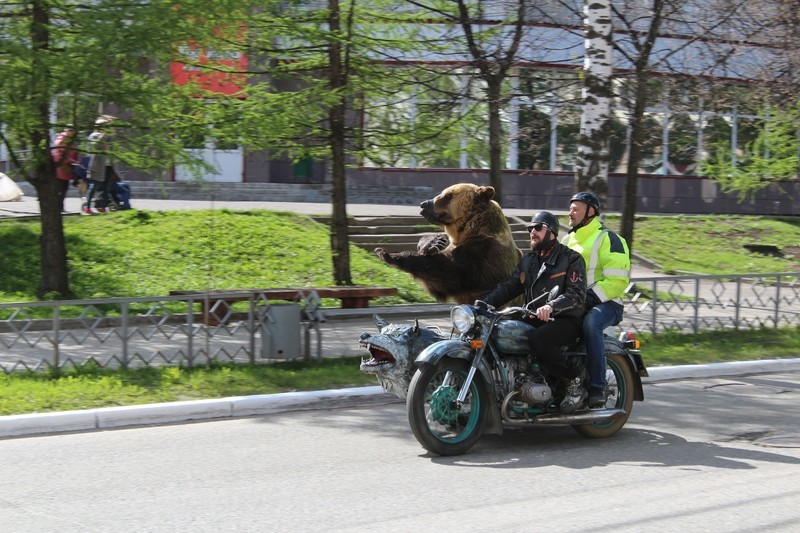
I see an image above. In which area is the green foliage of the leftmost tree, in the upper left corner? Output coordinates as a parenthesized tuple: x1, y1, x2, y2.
(0, 0, 244, 175)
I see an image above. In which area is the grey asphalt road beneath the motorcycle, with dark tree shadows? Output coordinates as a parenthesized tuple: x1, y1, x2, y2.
(0, 372, 800, 533)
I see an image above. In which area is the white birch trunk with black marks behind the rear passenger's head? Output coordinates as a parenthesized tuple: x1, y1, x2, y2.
(575, 0, 613, 198)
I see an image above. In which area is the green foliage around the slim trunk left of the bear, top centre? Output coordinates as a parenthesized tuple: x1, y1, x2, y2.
(225, 0, 460, 165)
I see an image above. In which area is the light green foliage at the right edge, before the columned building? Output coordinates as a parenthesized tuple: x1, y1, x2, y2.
(700, 109, 800, 201)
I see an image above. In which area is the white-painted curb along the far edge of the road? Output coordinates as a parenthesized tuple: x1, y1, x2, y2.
(0, 358, 800, 438)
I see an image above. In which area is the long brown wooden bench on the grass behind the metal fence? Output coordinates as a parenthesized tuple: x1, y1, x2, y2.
(169, 285, 397, 326)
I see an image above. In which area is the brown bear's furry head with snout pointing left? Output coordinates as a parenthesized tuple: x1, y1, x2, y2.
(420, 183, 510, 244)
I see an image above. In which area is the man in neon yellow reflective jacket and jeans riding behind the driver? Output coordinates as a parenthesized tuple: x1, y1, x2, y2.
(561, 191, 631, 409)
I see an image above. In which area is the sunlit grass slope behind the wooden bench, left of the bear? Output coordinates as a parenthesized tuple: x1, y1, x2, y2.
(0, 209, 433, 304)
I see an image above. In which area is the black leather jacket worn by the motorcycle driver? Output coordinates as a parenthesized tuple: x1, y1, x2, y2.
(483, 243, 586, 318)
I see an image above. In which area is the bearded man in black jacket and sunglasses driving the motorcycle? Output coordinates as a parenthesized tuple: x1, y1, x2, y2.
(484, 211, 586, 413)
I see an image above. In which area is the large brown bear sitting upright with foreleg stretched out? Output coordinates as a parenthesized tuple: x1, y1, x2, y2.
(375, 183, 522, 304)
